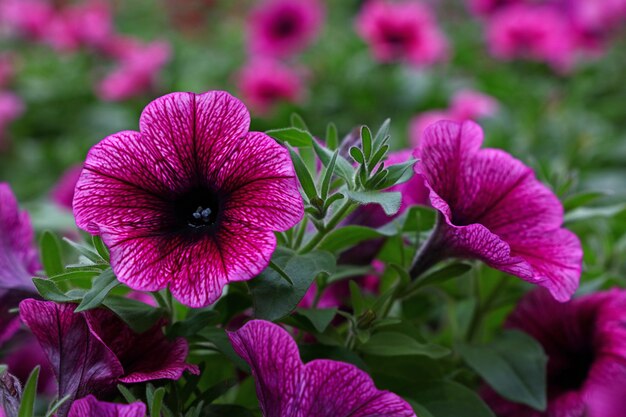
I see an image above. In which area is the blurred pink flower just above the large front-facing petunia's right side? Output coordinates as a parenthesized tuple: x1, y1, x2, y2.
(237, 58, 304, 113)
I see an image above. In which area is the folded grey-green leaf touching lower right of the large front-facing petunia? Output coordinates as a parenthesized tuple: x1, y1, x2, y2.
(249, 251, 335, 321)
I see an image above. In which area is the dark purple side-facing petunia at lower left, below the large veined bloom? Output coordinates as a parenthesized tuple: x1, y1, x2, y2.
(20, 299, 198, 415)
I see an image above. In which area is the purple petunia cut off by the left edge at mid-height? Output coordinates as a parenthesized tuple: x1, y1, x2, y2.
(0, 183, 41, 344)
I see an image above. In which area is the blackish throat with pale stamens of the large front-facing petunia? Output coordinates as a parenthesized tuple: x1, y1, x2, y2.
(173, 187, 220, 231)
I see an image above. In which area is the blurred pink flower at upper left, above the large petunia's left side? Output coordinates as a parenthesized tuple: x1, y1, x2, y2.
(97, 41, 171, 101)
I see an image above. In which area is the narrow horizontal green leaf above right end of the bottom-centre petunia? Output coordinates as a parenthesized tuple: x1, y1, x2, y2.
(359, 332, 450, 359)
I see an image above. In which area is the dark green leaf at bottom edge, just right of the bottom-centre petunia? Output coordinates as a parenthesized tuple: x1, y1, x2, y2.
(411, 381, 495, 417)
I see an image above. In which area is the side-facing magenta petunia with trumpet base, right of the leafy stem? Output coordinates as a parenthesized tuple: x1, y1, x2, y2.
(412, 121, 582, 301)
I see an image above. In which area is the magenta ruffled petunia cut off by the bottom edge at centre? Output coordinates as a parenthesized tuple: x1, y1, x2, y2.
(228, 320, 415, 417)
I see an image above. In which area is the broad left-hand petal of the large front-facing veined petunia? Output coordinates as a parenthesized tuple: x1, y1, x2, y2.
(73, 132, 180, 235)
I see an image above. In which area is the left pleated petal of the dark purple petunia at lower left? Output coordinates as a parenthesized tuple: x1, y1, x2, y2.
(20, 299, 123, 416)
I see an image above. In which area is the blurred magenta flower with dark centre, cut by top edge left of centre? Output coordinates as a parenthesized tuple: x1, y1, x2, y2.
(248, 0, 324, 57)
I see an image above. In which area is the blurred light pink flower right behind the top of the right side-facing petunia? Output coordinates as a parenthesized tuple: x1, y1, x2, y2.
(409, 89, 499, 147)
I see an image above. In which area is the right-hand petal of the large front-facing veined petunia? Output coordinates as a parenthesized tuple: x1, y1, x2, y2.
(221, 132, 304, 231)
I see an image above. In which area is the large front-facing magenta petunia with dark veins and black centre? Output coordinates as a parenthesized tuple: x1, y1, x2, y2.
(74, 91, 304, 307)
